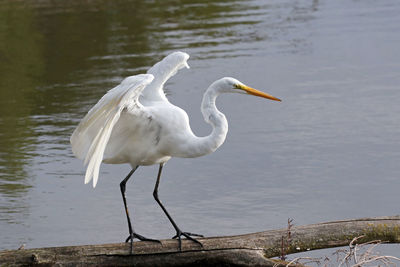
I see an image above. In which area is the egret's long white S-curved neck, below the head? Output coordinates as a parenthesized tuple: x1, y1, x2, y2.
(176, 84, 228, 157)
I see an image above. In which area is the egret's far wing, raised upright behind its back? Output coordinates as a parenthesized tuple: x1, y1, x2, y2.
(141, 51, 189, 101)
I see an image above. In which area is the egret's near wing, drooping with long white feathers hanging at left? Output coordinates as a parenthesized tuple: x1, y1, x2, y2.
(70, 74, 154, 187)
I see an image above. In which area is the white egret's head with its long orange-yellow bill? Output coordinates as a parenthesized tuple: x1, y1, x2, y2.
(215, 77, 281, 101)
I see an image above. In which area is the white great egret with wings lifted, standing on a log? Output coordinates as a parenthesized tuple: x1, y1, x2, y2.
(71, 52, 280, 251)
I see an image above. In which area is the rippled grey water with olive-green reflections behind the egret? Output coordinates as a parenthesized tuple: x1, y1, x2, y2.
(0, 0, 400, 256)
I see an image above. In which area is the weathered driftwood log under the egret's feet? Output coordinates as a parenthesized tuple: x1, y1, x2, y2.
(0, 216, 400, 267)
